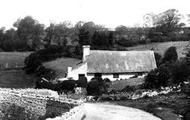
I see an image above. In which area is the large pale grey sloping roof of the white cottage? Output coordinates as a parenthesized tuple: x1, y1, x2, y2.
(86, 50, 156, 73)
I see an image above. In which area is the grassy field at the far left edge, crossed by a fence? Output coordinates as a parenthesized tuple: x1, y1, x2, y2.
(0, 52, 36, 88)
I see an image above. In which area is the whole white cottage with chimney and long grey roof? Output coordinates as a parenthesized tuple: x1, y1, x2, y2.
(67, 45, 157, 81)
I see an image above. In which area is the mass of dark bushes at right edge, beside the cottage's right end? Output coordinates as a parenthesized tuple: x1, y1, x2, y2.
(144, 46, 190, 88)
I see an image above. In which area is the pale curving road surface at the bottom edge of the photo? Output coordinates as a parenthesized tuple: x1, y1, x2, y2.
(84, 103, 161, 120)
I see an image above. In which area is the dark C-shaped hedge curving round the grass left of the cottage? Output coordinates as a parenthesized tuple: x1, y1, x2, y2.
(24, 46, 64, 80)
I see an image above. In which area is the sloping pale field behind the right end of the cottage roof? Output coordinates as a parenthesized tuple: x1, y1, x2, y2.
(126, 41, 189, 58)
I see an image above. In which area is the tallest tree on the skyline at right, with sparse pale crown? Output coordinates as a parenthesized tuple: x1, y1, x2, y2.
(149, 9, 185, 41)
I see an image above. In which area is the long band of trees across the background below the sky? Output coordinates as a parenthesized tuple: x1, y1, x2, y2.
(0, 9, 190, 51)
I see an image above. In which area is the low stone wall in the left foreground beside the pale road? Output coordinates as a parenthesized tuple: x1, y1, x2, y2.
(0, 88, 82, 120)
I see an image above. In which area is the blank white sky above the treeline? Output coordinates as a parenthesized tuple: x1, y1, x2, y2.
(0, 0, 190, 29)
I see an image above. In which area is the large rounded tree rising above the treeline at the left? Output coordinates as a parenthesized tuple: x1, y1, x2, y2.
(13, 16, 44, 50)
